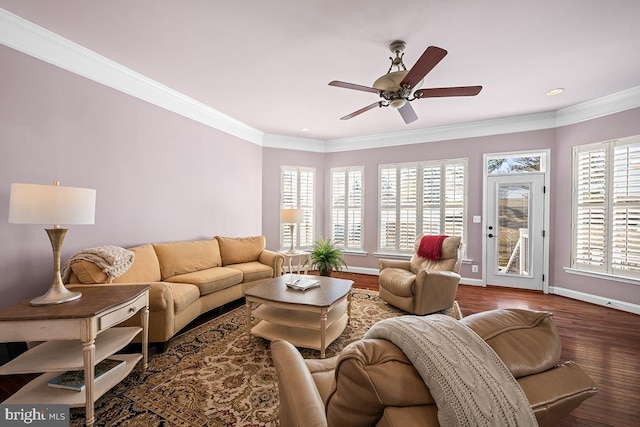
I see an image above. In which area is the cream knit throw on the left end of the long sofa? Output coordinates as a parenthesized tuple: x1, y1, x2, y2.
(62, 245, 135, 283)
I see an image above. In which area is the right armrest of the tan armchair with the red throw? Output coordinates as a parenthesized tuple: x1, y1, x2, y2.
(413, 270, 460, 316)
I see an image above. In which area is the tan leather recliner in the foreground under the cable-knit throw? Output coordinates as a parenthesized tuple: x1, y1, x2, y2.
(271, 309, 597, 427)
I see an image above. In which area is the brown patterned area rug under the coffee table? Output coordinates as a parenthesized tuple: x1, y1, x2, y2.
(71, 289, 403, 427)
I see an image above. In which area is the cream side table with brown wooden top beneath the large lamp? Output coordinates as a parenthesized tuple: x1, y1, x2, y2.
(0, 285, 150, 426)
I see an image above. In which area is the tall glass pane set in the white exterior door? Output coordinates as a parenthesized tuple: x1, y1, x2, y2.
(495, 184, 531, 277)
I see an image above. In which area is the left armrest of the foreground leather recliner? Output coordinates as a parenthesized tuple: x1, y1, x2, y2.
(271, 340, 327, 427)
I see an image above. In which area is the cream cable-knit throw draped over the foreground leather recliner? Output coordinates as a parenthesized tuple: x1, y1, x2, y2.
(365, 314, 538, 427)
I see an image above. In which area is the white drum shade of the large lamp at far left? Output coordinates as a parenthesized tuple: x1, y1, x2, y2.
(9, 184, 96, 225)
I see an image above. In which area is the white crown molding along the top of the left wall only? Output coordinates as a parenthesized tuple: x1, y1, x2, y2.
(0, 8, 263, 145)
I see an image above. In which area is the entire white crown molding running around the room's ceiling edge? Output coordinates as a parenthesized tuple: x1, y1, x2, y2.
(0, 8, 640, 153)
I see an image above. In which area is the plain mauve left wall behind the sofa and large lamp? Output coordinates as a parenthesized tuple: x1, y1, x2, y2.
(0, 46, 262, 306)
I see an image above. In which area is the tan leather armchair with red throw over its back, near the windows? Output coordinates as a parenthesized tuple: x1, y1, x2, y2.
(378, 235, 462, 316)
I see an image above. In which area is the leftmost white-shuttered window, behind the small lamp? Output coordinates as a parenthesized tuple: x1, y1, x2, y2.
(280, 166, 316, 249)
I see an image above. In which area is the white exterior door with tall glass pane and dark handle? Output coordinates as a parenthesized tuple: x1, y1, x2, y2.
(485, 173, 545, 291)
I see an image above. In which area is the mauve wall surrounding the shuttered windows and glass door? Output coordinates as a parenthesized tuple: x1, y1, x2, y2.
(263, 109, 640, 304)
